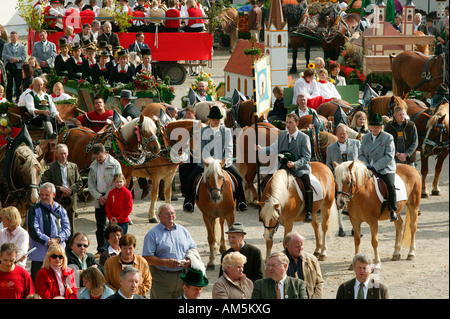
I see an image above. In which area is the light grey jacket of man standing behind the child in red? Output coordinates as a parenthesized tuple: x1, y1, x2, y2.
(88, 154, 122, 208)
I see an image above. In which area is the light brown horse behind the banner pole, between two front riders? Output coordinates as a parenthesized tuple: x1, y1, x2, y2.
(236, 122, 279, 203)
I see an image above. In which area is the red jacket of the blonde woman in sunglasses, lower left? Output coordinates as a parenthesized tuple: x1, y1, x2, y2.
(35, 267, 77, 299)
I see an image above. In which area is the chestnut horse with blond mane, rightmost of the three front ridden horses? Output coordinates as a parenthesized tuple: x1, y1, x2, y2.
(334, 161, 422, 265)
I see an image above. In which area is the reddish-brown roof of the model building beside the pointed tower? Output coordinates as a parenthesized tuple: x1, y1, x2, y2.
(223, 39, 264, 77)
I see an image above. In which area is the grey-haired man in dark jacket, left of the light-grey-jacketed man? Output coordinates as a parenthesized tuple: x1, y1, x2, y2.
(41, 144, 83, 238)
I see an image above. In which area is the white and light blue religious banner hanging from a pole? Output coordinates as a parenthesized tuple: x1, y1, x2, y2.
(254, 55, 272, 117)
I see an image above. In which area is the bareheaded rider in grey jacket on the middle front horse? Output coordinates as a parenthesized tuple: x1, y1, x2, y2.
(256, 113, 314, 223)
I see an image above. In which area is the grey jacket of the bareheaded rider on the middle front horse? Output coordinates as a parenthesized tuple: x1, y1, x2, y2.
(262, 130, 311, 177)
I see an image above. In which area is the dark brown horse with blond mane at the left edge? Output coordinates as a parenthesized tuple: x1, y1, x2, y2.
(0, 143, 43, 228)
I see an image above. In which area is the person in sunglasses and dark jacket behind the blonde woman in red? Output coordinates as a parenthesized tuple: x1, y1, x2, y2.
(66, 232, 105, 282)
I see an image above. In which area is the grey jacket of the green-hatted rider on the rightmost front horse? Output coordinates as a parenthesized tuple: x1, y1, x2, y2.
(359, 131, 397, 175)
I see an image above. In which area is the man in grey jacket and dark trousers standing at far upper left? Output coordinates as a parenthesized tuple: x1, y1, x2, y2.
(2, 31, 27, 102)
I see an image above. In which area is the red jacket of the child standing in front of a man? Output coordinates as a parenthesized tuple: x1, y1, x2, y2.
(105, 186, 133, 224)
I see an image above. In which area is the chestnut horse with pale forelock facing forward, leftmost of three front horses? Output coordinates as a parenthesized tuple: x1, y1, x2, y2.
(196, 158, 237, 270)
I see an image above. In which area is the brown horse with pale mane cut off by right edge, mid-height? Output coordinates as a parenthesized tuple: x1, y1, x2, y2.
(421, 103, 450, 197)
